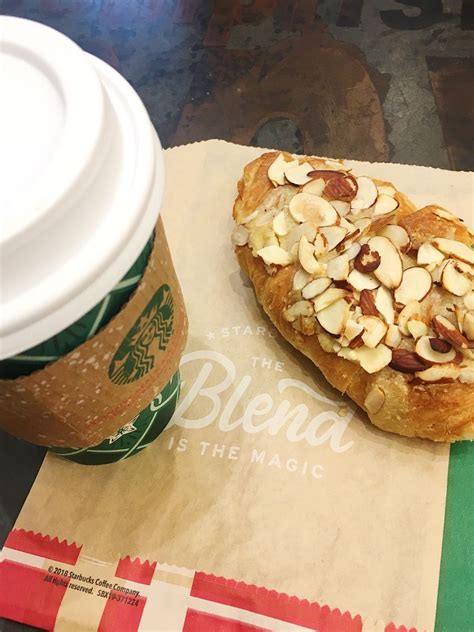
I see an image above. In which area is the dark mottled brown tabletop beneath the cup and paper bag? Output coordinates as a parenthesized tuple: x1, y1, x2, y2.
(0, 0, 474, 632)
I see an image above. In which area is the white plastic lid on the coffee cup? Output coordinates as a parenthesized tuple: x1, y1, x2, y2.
(0, 16, 164, 359)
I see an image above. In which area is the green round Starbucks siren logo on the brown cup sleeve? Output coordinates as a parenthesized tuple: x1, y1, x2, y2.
(109, 284, 173, 384)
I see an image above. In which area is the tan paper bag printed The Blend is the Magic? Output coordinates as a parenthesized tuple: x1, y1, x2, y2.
(7, 141, 472, 632)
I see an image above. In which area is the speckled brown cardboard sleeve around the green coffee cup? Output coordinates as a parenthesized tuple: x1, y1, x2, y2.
(0, 218, 187, 448)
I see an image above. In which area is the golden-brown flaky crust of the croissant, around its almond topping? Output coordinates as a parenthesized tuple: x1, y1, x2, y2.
(233, 152, 474, 442)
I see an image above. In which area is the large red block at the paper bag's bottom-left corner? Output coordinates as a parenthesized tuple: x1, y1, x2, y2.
(0, 560, 69, 630)
